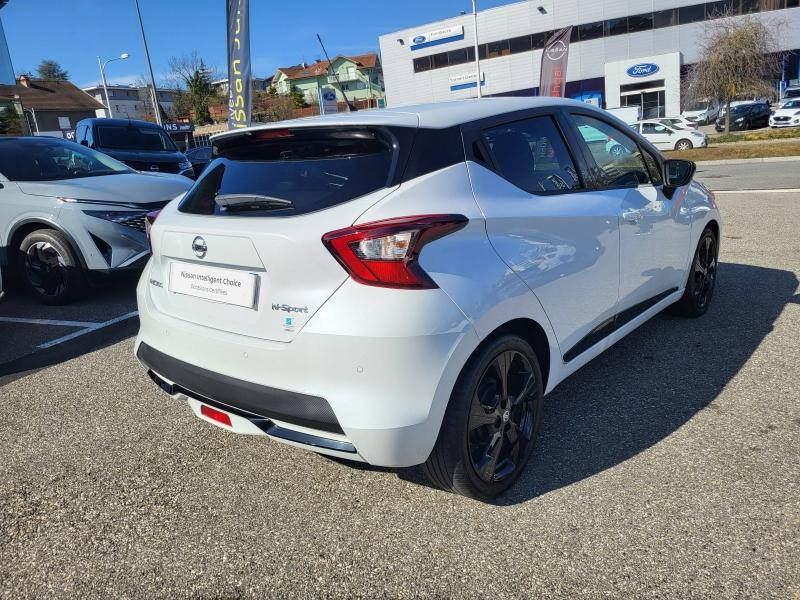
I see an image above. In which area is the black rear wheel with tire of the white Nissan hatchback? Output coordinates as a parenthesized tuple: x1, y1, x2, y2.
(425, 335, 544, 500)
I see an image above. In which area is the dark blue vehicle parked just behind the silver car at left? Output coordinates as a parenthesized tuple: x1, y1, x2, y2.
(75, 119, 194, 179)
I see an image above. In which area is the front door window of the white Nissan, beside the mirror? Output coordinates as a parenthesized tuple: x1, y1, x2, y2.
(572, 115, 652, 187)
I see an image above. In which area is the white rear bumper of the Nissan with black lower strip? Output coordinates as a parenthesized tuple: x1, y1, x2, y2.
(136, 268, 477, 467)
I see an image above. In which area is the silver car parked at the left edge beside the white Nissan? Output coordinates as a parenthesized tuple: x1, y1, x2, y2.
(0, 137, 192, 304)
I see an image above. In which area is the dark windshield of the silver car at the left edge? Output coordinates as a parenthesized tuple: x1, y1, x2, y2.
(0, 137, 132, 181)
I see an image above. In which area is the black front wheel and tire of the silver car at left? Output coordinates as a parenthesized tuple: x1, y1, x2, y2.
(17, 229, 86, 305)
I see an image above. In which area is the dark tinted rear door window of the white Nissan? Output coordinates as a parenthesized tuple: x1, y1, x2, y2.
(483, 116, 582, 194)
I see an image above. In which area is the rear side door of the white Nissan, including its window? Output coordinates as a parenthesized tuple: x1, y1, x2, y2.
(464, 111, 620, 360)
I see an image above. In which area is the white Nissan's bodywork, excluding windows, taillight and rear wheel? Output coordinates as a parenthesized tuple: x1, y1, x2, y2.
(135, 98, 720, 492)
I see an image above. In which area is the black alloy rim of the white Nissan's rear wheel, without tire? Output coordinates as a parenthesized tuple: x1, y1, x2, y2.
(467, 350, 536, 483)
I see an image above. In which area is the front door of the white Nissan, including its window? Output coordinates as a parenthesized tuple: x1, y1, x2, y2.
(571, 113, 691, 312)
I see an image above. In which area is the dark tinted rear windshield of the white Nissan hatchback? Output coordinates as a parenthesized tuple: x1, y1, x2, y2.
(179, 127, 397, 217)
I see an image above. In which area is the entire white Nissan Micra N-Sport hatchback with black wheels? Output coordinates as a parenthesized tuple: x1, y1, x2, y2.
(135, 98, 720, 499)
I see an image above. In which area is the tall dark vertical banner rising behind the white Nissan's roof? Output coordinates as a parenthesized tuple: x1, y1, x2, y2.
(228, 0, 253, 129)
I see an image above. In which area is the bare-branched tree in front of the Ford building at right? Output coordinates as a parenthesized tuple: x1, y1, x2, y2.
(686, 10, 780, 133)
